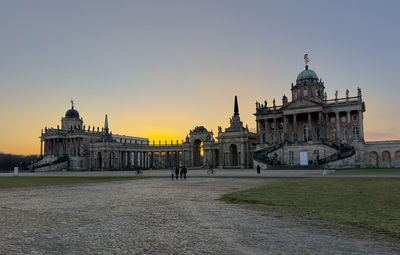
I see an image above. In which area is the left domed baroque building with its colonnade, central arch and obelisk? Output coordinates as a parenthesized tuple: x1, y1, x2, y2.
(33, 97, 257, 171)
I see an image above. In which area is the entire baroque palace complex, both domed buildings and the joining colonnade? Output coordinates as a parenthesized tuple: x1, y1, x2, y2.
(32, 54, 400, 171)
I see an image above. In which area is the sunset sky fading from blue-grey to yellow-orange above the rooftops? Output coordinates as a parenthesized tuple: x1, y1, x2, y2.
(0, 0, 400, 154)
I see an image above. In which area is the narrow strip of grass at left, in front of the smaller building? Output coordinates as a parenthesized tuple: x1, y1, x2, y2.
(0, 176, 146, 189)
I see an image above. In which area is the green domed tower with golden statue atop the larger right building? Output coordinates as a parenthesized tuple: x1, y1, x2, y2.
(292, 54, 325, 102)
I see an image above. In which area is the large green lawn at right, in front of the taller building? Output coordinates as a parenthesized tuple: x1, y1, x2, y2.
(221, 178, 400, 238)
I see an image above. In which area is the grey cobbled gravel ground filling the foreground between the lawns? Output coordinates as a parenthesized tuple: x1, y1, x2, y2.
(0, 178, 400, 254)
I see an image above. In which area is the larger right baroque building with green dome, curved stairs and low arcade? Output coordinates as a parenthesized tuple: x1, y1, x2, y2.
(254, 54, 400, 168)
